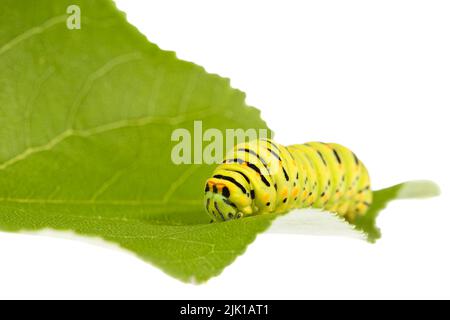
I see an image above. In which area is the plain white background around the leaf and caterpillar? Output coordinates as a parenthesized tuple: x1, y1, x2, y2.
(0, 0, 450, 299)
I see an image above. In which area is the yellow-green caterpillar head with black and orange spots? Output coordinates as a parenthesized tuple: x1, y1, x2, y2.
(205, 175, 252, 222)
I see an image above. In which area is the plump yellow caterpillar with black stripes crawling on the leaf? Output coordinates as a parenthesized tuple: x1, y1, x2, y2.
(204, 139, 372, 223)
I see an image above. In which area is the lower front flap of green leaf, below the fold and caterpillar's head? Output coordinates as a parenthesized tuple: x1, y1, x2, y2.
(0, 205, 274, 283)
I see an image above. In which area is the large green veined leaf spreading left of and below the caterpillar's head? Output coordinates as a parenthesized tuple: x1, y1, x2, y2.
(0, 0, 271, 281)
